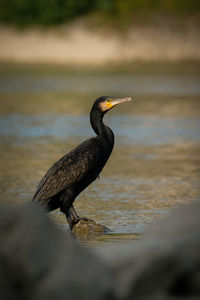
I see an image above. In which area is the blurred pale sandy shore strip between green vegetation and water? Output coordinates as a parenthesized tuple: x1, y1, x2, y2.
(0, 22, 200, 65)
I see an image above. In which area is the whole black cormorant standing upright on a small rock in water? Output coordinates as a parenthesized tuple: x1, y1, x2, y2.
(32, 96, 131, 229)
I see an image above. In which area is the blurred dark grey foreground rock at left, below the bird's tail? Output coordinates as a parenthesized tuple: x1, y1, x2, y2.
(0, 204, 112, 300)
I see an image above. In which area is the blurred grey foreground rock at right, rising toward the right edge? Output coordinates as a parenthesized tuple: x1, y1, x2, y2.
(96, 203, 200, 300)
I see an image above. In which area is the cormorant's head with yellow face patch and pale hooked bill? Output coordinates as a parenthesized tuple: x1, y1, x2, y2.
(94, 96, 132, 113)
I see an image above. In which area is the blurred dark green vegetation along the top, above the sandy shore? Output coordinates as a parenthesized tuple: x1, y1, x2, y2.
(0, 0, 200, 26)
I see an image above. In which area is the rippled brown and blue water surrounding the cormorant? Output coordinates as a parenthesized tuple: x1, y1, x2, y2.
(0, 64, 200, 242)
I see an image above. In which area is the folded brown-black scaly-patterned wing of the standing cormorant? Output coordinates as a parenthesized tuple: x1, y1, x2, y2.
(33, 139, 100, 202)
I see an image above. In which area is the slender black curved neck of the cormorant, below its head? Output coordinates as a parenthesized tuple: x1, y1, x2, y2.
(90, 109, 114, 147)
